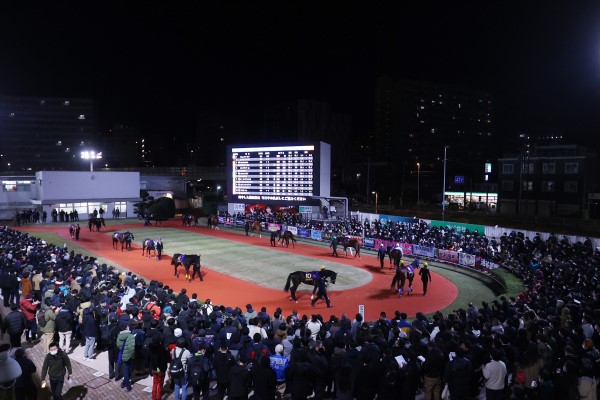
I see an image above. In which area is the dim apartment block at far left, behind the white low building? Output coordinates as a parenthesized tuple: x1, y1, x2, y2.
(0, 96, 96, 170)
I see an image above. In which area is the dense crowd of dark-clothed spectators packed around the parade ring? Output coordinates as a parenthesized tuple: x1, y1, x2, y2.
(0, 221, 600, 400)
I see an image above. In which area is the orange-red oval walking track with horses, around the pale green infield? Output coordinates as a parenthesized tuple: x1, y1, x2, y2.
(21, 220, 458, 321)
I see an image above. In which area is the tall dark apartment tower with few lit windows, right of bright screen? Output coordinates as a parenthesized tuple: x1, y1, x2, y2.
(372, 77, 494, 164)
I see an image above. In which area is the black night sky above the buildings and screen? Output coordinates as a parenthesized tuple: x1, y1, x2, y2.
(0, 0, 600, 148)
